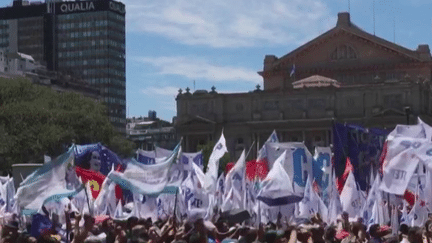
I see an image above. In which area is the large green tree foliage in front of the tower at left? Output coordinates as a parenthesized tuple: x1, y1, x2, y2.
(0, 78, 133, 170)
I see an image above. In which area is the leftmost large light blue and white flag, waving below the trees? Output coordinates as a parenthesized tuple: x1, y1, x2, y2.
(15, 146, 83, 213)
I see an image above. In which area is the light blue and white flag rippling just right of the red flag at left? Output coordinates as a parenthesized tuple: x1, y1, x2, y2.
(107, 143, 181, 195)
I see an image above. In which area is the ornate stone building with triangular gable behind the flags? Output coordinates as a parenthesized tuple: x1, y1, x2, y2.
(175, 13, 432, 159)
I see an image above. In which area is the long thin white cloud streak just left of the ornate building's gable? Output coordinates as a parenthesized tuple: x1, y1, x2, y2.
(134, 56, 262, 84)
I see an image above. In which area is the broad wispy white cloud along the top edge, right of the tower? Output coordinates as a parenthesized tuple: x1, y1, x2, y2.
(123, 0, 330, 47)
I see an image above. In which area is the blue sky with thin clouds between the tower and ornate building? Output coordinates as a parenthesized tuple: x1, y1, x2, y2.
(0, 0, 432, 121)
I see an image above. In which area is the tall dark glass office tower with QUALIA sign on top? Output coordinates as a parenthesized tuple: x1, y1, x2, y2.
(0, 0, 126, 133)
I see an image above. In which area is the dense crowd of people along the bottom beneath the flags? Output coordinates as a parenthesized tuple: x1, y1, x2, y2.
(0, 210, 432, 243)
